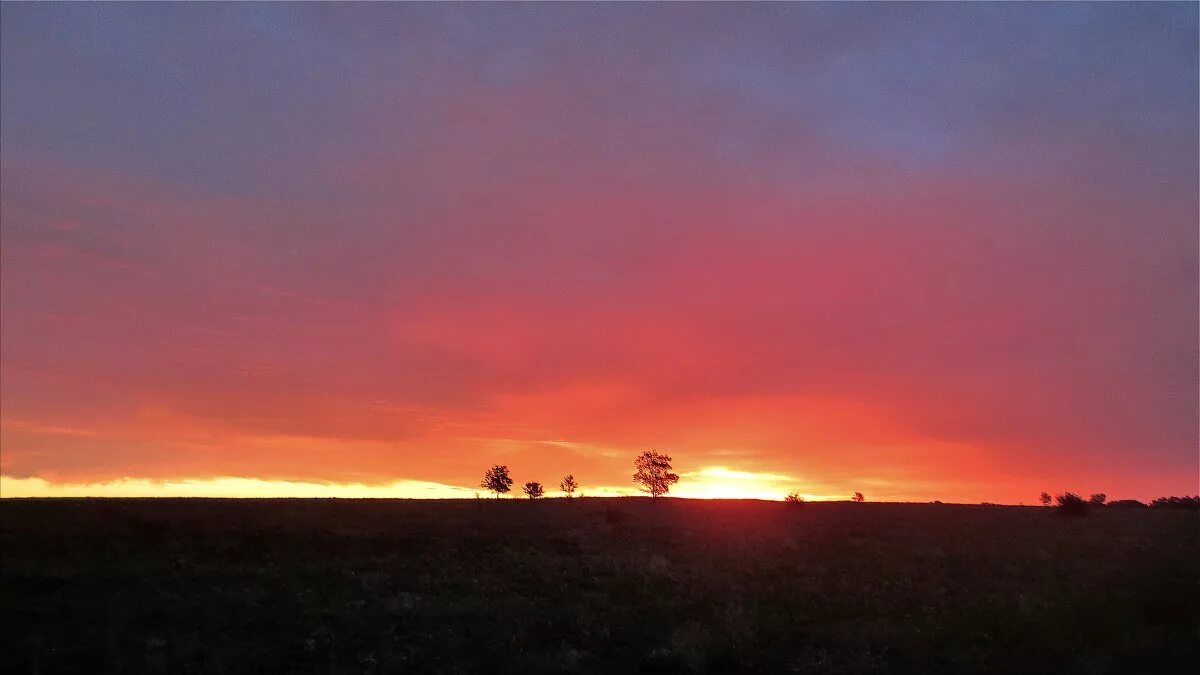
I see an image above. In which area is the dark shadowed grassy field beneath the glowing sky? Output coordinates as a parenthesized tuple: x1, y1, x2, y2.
(0, 498, 1200, 673)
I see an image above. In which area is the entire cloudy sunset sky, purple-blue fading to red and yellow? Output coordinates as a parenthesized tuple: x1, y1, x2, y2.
(0, 2, 1200, 503)
